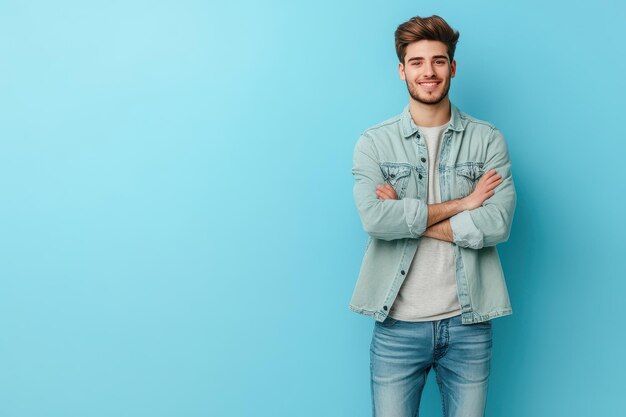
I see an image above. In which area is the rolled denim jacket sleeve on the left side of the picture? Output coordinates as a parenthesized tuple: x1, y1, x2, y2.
(352, 134, 428, 240)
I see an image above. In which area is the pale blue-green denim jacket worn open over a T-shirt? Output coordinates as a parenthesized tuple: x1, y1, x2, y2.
(350, 105, 516, 324)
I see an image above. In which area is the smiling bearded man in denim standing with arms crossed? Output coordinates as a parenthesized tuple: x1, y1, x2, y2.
(350, 16, 515, 417)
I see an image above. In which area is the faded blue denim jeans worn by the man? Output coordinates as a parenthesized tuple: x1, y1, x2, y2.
(370, 315, 492, 417)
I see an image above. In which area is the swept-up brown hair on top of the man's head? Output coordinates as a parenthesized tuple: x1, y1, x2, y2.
(396, 15, 459, 64)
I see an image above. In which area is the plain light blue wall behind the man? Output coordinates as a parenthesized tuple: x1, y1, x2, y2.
(0, 0, 626, 417)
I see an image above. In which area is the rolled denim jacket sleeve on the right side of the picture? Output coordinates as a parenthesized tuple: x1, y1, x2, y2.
(450, 128, 516, 249)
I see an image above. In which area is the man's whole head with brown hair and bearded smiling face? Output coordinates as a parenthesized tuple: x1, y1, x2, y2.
(395, 16, 459, 104)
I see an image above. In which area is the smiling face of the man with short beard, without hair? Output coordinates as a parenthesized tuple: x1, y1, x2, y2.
(398, 40, 456, 105)
